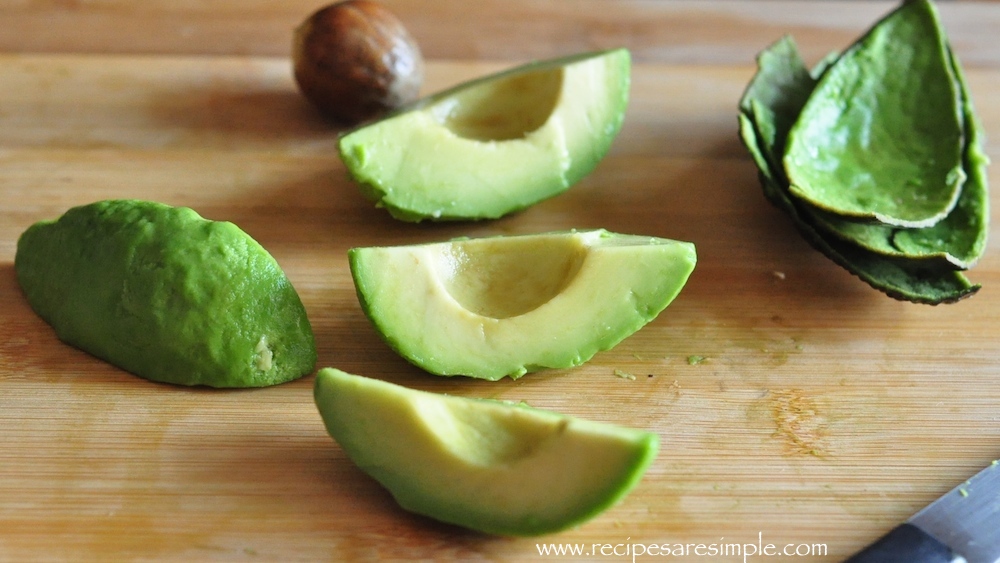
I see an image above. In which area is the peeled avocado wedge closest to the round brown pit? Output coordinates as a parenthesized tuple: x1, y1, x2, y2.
(339, 49, 631, 221)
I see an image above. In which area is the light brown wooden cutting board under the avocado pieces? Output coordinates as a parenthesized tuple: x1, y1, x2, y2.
(0, 0, 1000, 562)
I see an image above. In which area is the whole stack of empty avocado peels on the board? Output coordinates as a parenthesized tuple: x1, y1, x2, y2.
(739, 0, 989, 305)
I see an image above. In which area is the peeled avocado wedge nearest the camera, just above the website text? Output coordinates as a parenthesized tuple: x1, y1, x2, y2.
(314, 368, 659, 536)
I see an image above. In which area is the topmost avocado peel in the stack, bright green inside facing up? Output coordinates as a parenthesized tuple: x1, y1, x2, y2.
(784, 0, 965, 228)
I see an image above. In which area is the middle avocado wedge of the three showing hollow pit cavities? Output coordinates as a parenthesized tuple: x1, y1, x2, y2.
(349, 230, 696, 380)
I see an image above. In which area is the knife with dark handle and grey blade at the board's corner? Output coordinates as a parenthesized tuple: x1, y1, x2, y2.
(845, 461, 1000, 563)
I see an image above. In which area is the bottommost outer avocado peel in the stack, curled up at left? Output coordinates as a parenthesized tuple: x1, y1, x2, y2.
(739, 37, 979, 305)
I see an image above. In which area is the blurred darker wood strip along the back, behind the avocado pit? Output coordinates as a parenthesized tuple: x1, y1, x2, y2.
(0, 0, 1000, 66)
